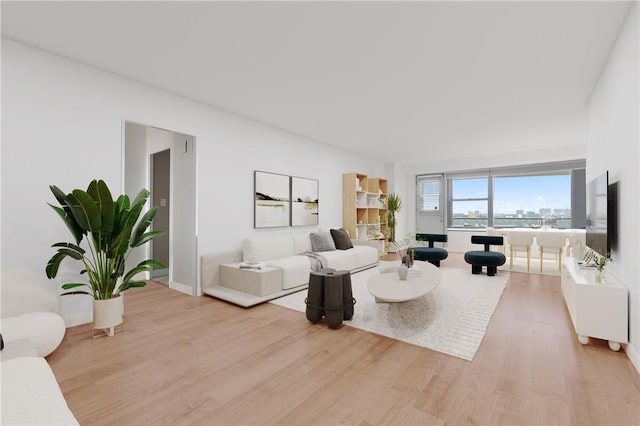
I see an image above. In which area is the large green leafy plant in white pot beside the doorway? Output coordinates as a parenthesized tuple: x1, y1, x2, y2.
(46, 180, 164, 336)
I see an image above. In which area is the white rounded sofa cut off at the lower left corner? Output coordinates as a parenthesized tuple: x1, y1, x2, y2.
(0, 266, 78, 425)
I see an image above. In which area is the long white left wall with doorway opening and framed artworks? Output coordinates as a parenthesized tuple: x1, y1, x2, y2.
(1, 39, 384, 326)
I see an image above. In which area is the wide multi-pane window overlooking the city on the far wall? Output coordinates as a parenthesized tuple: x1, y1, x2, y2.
(446, 160, 585, 229)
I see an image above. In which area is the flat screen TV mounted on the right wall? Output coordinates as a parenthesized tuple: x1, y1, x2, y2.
(586, 171, 611, 255)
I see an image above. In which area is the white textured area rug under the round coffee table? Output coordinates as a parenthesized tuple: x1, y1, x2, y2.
(271, 266, 509, 361)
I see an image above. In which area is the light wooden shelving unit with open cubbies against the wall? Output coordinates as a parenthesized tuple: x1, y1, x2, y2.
(342, 173, 388, 252)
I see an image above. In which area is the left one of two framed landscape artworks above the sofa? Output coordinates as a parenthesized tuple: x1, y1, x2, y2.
(253, 170, 291, 228)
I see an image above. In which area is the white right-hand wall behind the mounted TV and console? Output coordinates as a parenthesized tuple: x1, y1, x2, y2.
(587, 2, 640, 370)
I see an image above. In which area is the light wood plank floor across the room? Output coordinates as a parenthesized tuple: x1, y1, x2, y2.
(48, 254, 640, 425)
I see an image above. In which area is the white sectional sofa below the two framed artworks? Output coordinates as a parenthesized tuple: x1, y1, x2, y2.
(201, 232, 379, 307)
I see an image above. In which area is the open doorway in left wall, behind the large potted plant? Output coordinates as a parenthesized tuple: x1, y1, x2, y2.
(124, 121, 198, 296)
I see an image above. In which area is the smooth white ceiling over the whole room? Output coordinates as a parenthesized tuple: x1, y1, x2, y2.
(2, 1, 631, 164)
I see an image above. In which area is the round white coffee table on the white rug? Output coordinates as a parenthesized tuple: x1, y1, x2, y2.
(367, 260, 441, 302)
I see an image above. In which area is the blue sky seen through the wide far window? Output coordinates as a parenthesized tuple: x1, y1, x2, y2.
(453, 175, 571, 214)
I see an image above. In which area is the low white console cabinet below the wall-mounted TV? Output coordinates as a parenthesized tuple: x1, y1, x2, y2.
(561, 257, 629, 351)
